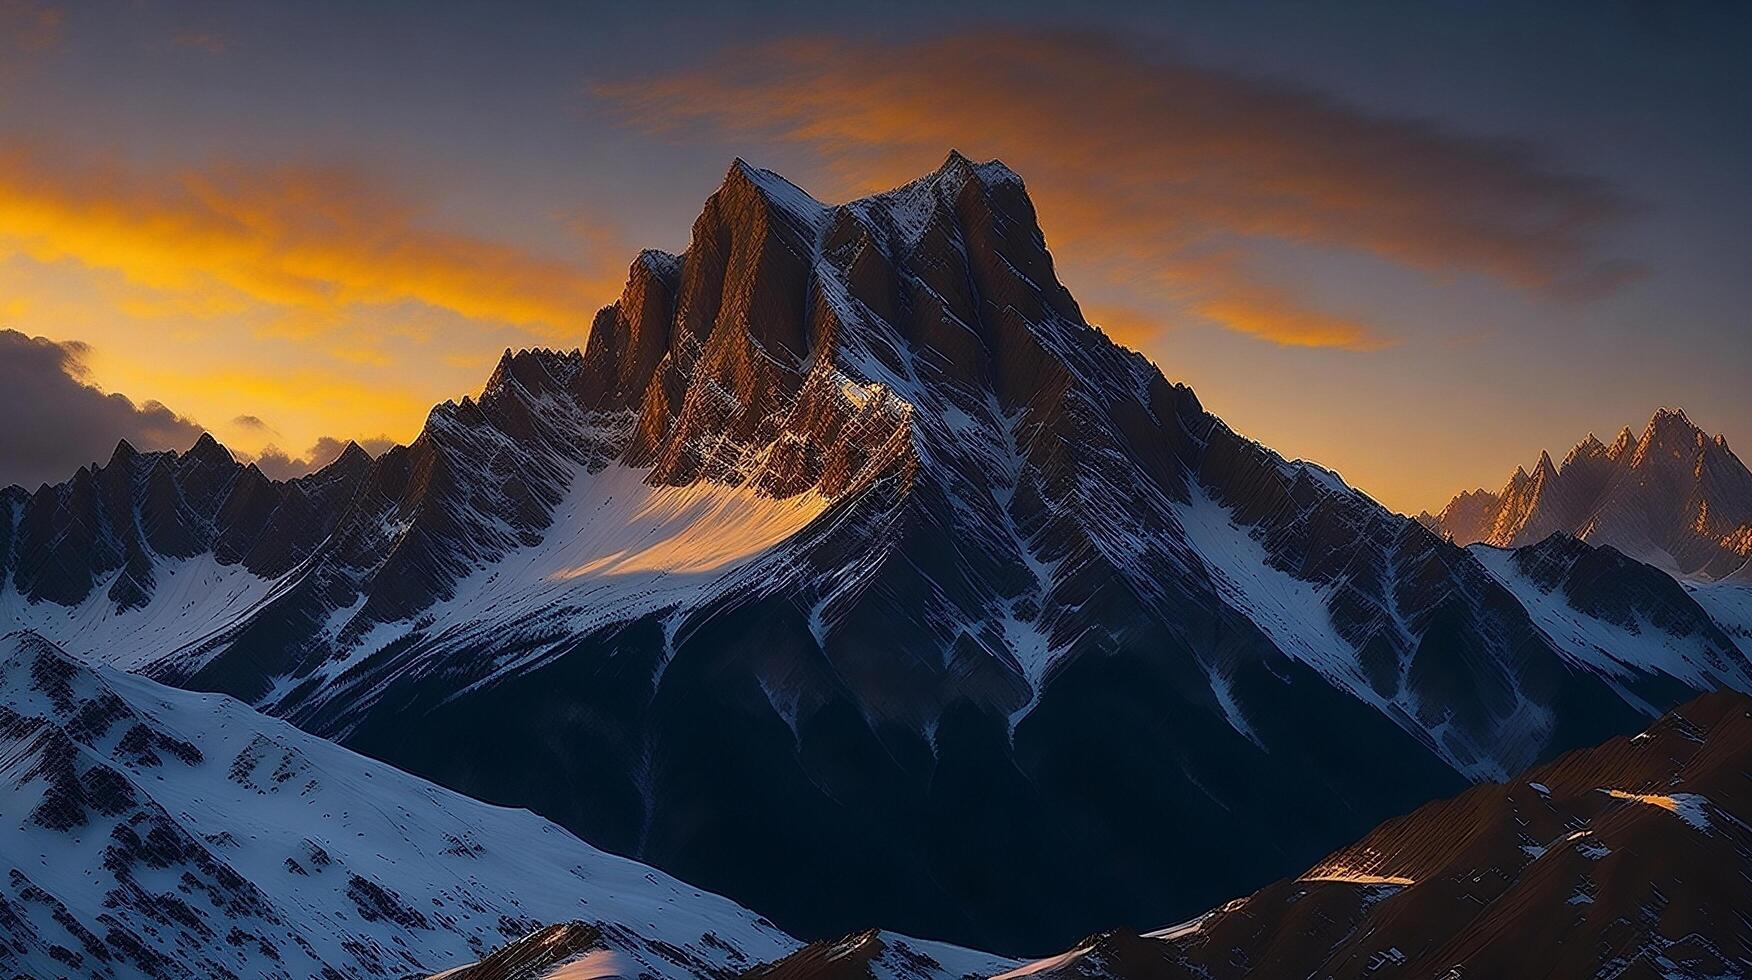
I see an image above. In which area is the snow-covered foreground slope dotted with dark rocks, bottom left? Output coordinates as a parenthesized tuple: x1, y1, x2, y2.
(0, 633, 797, 980)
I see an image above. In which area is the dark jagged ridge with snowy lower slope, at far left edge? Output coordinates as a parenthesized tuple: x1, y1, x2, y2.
(0, 435, 373, 670)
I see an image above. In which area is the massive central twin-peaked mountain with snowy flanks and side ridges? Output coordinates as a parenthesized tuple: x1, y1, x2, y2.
(0, 154, 1752, 954)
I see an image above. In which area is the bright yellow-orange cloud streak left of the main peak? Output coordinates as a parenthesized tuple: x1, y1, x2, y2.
(0, 151, 620, 333)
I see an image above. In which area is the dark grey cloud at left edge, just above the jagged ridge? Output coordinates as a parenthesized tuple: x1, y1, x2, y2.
(0, 330, 201, 489)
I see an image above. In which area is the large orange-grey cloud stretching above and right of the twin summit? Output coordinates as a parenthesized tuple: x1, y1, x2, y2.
(594, 30, 1633, 349)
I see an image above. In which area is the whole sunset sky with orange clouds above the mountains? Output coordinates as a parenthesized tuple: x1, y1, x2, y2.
(0, 0, 1752, 512)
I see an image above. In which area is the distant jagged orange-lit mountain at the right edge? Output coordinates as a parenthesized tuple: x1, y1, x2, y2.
(1421, 408, 1752, 579)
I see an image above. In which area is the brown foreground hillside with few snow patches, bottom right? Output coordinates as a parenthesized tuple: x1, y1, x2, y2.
(988, 692, 1752, 980)
